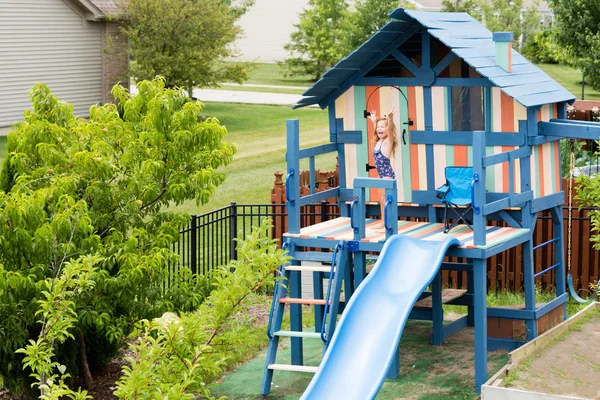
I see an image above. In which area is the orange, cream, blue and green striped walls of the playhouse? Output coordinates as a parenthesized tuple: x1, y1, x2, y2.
(336, 86, 560, 203)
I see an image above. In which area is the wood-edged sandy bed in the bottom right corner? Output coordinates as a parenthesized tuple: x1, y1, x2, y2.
(481, 303, 600, 400)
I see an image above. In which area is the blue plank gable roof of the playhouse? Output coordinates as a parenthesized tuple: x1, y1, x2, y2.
(294, 8, 575, 108)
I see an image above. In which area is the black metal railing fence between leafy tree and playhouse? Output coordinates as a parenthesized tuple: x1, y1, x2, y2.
(174, 202, 340, 275)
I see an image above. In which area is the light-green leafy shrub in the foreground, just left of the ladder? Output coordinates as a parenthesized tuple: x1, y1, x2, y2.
(115, 220, 288, 399)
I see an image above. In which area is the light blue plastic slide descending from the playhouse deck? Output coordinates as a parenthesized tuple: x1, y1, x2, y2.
(301, 235, 460, 400)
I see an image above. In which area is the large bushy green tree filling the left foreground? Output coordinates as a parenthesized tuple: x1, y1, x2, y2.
(0, 78, 235, 394)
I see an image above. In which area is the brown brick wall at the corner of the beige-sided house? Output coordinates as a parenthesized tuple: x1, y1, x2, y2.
(102, 21, 129, 103)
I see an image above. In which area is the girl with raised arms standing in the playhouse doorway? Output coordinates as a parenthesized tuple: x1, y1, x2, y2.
(369, 108, 398, 228)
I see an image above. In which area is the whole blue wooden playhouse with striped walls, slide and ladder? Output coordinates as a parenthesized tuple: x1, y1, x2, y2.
(262, 8, 600, 399)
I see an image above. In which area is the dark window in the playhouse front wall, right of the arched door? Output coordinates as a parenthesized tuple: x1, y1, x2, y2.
(452, 86, 485, 131)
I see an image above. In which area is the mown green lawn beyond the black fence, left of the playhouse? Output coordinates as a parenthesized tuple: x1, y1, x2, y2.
(171, 103, 336, 214)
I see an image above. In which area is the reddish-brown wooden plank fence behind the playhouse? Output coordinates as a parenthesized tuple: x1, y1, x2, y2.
(271, 170, 600, 297)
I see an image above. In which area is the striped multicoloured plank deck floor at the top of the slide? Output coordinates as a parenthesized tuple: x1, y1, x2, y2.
(285, 217, 529, 249)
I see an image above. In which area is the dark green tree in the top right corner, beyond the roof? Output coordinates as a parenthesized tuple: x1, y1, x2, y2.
(549, 0, 600, 90)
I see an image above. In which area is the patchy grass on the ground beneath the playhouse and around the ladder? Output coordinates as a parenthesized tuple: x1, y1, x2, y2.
(213, 292, 582, 400)
